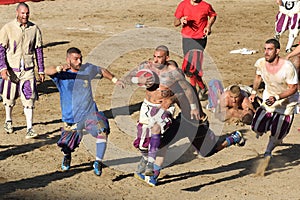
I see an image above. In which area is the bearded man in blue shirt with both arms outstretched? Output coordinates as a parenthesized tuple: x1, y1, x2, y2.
(45, 47, 125, 176)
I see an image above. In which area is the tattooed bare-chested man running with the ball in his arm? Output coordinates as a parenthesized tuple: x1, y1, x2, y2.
(131, 45, 206, 176)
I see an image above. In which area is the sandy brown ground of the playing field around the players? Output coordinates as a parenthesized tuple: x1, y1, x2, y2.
(0, 0, 300, 200)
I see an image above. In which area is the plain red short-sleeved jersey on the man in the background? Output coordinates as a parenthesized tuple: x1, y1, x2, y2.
(174, 0, 217, 39)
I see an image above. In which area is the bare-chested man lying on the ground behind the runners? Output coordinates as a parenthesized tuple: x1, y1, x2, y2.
(215, 85, 255, 125)
